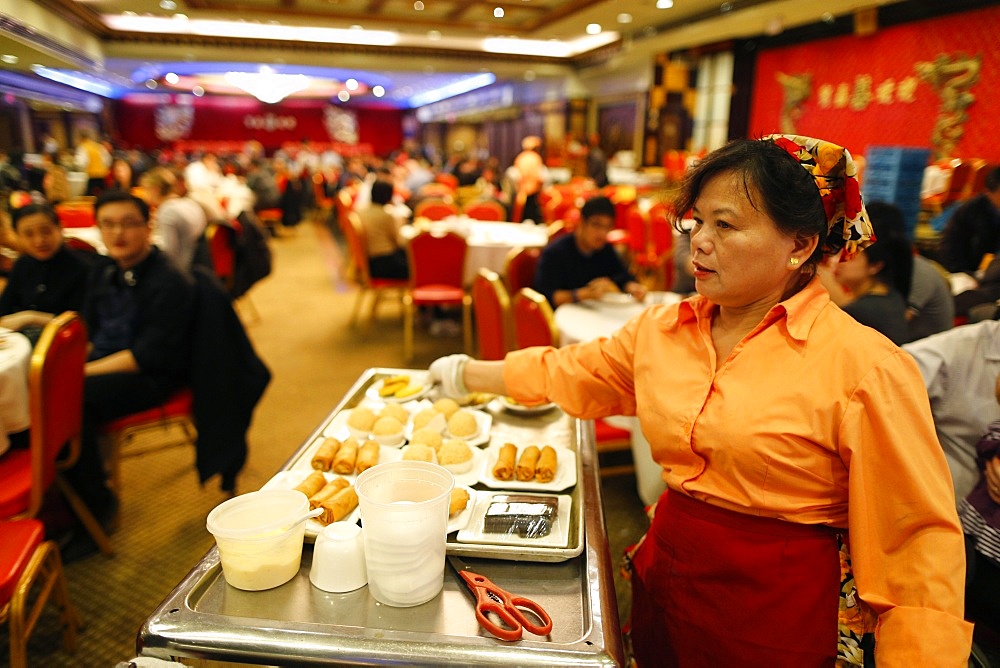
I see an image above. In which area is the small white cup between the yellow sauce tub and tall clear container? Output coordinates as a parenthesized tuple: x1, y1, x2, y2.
(309, 522, 368, 594)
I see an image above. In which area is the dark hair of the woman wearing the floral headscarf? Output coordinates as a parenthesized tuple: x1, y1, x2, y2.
(674, 139, 828, 266)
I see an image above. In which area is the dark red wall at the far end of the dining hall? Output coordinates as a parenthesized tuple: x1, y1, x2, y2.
(115, 96, 403, 155)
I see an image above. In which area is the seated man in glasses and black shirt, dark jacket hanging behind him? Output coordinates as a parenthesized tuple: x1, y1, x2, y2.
(68, 190, 196, 536)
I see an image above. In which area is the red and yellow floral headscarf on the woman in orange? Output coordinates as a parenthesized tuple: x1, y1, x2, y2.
(765, 135, 875, 260)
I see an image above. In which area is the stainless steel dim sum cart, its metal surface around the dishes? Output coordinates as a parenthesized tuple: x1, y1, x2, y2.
(137, 368, 624, 666)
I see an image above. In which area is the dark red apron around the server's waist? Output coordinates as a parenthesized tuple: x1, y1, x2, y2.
(631, 492, 840, 668)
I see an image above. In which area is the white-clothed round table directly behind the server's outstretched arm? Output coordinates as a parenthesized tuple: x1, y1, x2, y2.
(555, 292, 683, 506)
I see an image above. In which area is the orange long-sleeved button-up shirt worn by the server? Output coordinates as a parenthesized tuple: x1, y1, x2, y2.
(504, 280, 972, 666)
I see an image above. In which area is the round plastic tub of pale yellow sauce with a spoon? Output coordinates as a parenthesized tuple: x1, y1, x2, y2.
(207, 489, 309, 591)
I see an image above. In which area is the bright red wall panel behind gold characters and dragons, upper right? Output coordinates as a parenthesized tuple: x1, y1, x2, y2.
(748, 7, 1000, 162)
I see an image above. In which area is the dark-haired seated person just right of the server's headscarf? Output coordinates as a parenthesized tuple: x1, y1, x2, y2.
(831, 205, 913, 345)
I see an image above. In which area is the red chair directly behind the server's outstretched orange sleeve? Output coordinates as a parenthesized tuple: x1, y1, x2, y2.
(512, 288, 635, 476)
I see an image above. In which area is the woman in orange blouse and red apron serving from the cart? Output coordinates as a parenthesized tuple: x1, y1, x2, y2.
(431, 136, 972, 668)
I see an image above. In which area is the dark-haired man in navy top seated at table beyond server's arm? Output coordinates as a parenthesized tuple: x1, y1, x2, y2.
(534, 197, 646, 308)
